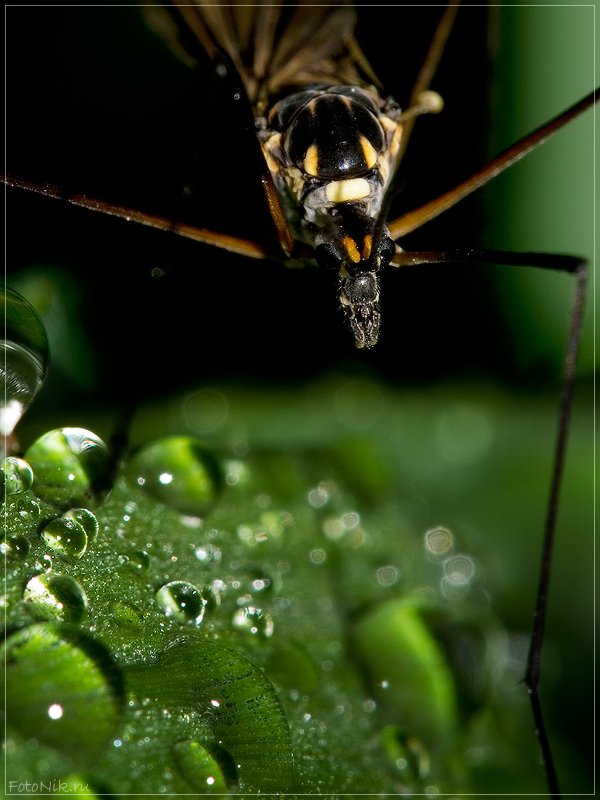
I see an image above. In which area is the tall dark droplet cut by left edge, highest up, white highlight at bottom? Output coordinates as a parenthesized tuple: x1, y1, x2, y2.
(0, 287, 49, 436)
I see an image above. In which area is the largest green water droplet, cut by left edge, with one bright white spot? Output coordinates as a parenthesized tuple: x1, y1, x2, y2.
(2, 623, 124, 763)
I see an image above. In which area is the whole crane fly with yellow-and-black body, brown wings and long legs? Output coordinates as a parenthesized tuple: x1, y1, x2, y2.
(7, 4, 595, 794)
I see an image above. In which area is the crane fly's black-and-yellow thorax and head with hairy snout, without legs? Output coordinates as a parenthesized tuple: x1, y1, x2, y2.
(259, 84, 402, 347)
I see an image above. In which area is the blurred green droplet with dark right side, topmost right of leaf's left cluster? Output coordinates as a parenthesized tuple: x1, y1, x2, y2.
(127, 436, 223, 516)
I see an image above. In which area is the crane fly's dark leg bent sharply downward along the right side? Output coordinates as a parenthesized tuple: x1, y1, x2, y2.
(392, 250, 587, 797)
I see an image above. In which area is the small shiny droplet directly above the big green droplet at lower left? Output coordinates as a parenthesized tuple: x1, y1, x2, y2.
(23, 572, 87, 624)
